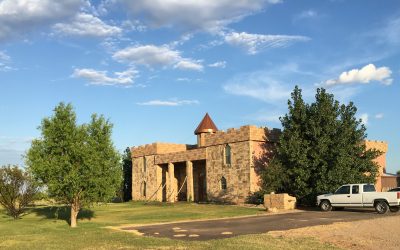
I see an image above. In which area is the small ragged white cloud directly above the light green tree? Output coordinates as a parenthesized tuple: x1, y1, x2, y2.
(72, 69, 138, 86)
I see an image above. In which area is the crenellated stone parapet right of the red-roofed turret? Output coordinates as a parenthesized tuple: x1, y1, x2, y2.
(204, 125, 281, 147)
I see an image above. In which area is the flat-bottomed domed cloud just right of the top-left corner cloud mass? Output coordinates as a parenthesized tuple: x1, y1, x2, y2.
(53, 13, 122, 37)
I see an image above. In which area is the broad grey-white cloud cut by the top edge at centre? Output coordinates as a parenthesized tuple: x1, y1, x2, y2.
(122, 0, 281, 30)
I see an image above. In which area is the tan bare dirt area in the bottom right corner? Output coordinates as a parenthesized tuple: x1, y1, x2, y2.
(269, 213, 400, 249)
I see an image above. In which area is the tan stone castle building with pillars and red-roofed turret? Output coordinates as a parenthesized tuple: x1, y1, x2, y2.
(131, 114, 397, 204)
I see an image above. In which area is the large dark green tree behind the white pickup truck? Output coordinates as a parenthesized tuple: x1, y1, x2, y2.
(263, 86, 380, 204)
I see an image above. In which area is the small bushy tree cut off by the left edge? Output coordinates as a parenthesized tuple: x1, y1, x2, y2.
(0, 165, 38, 219)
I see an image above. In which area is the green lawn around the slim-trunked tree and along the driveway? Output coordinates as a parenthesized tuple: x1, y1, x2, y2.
(0, 202, 333, 249)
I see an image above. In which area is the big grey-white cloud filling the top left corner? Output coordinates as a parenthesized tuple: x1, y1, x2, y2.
(0, 0, 83, 41)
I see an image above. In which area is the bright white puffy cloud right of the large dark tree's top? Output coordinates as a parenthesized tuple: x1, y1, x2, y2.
(324, 64, 393, 86)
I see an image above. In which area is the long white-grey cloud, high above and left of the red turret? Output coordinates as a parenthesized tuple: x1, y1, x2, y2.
(113, 45, 203, 71)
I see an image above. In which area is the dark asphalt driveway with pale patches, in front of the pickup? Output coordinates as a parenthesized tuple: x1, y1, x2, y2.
(121, 210, 400, 240)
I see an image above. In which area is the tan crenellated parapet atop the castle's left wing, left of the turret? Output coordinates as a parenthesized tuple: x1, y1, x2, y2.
(131, 142, 188, 158)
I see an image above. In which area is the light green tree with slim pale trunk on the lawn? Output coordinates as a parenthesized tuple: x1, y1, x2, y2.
(26, 103, 121, 227)
